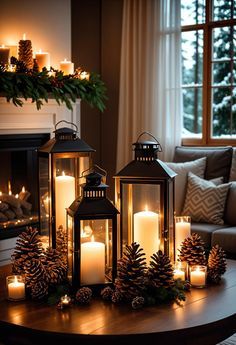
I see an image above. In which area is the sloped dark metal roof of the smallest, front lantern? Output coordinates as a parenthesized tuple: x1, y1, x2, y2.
(67, 197, 119, 217)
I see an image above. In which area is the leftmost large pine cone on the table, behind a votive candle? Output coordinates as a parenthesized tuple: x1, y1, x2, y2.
(12, 227, 43, 274)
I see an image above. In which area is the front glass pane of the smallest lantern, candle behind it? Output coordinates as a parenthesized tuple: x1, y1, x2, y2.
(80, 219, 113, 285)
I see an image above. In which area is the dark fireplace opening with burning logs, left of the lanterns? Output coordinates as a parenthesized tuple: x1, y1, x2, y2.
(0, 133, 50, 239)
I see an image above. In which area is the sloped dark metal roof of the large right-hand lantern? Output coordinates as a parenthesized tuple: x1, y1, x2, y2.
(114, 159, 177, 180)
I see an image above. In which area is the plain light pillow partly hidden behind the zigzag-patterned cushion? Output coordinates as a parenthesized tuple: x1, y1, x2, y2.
(166, 157, 206, 216)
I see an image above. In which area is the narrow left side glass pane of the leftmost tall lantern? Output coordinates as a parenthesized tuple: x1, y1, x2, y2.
(39, 157, 51, 247)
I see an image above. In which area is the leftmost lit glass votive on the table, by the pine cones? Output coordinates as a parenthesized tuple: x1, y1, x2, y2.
(6, 275, 25, 301)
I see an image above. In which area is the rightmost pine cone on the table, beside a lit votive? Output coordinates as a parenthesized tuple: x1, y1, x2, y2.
(207, 244, 227, 284)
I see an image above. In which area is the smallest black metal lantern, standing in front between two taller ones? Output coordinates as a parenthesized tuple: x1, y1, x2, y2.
(67, 166, 119, 288)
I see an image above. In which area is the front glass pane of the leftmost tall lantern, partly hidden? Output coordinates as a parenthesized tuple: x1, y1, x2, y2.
(54, 153, 89, 229)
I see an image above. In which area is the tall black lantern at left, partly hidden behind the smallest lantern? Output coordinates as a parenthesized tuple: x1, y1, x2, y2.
(38, 120, 95, 247)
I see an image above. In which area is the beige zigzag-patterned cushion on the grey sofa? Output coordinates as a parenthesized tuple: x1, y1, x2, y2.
(182, 173, 230, 224)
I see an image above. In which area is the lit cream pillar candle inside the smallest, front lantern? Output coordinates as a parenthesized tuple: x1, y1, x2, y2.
(80, 236, 105, 285)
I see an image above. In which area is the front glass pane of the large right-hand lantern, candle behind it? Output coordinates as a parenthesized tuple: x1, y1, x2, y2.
(121, 183, 160, 263)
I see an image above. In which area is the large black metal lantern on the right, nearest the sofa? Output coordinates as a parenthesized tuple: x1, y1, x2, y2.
(115, 132, 176, 263)
